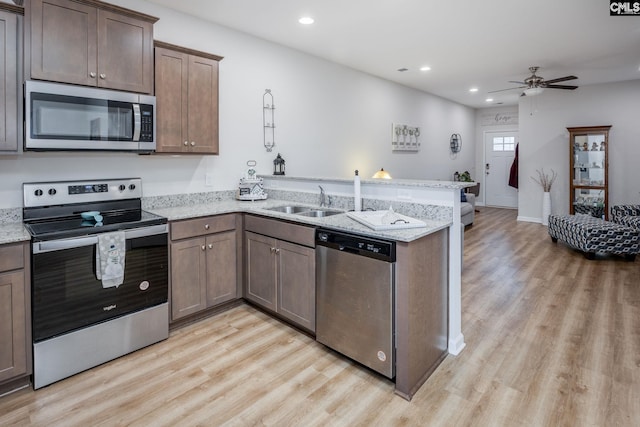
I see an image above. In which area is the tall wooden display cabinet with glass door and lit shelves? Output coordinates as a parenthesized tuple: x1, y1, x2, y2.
(567, 126, 611, 220)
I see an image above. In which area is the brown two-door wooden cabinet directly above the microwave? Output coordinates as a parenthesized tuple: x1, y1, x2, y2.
(25, 0, 157, 93)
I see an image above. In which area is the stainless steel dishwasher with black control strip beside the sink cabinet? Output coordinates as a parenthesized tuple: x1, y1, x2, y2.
(316, 229, 396, 378)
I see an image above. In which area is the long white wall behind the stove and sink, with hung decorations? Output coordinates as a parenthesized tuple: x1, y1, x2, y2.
(0, 0, 474, 208)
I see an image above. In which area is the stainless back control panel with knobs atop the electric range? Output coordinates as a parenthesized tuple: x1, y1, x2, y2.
(22, 178, 142, 208)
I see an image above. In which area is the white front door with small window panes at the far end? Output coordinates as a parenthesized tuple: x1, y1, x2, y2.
(484, 132, 518, 208)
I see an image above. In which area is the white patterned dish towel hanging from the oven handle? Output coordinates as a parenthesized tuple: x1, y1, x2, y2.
(96, 231, 127, 288)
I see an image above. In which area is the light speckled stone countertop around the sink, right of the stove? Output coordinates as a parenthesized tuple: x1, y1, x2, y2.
(149, 199, 452, 242)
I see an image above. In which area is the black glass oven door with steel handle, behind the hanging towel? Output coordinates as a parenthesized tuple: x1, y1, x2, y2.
(31, 224, 169, 342)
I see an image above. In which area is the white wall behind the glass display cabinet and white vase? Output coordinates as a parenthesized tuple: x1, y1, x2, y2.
(518, 80, 640, 222)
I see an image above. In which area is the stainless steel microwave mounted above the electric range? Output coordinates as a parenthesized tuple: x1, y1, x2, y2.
(24, 80, 156, 153)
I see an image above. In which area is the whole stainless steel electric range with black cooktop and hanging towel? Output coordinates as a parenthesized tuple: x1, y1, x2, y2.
(23, 178, 169, 389)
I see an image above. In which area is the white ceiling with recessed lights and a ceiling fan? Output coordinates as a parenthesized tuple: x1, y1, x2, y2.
(148, 0, 640, 108)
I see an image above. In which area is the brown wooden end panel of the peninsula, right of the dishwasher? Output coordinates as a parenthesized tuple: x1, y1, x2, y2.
(395, 229, 449, 400)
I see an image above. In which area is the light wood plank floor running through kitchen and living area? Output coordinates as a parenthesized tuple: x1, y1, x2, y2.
(0, 208, 640, 427)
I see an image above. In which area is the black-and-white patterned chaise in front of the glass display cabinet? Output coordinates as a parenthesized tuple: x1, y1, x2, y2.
(549, 215, 640, 261)
